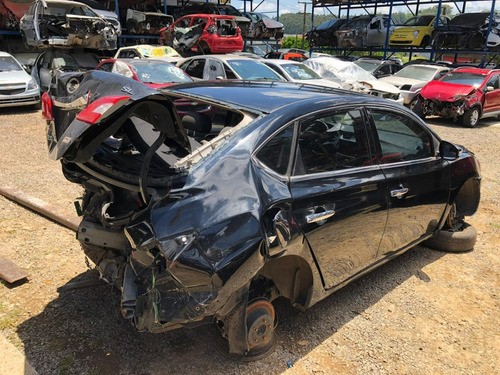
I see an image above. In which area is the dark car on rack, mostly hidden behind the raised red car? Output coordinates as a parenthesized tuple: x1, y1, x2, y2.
(175, 2, 252, 37)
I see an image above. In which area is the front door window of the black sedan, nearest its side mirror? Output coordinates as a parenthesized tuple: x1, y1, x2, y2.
(371, 109, 432, 164)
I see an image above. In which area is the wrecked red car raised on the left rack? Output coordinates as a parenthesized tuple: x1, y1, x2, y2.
(160, 14, 243, 56)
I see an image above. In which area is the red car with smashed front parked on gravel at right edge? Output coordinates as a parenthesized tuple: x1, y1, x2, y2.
(410, 68, 500, 128)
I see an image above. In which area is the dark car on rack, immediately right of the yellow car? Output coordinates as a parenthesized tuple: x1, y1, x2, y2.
(432, 13, 500, 50)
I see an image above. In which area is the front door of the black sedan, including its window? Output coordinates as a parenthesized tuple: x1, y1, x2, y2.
(367, 108, 450, 257)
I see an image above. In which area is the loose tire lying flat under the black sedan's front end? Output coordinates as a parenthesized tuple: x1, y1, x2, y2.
(423, 223, 477, 253)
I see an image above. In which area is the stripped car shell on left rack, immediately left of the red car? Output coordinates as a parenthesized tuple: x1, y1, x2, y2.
(126, 6, 174, 35)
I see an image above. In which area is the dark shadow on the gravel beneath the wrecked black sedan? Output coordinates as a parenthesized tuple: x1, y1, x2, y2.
(17, 246, 443, 375)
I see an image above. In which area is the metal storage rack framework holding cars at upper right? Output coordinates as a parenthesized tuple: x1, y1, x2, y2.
(311, 0, 497, 66)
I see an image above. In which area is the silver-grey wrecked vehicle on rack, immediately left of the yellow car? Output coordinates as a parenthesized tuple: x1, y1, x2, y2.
(335, 15, 395, 48)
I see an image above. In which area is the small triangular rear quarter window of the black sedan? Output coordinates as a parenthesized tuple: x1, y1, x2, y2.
(257, 126, 293, 175)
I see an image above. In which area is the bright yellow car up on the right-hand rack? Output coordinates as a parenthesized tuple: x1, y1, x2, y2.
(389, 14, 448, 48)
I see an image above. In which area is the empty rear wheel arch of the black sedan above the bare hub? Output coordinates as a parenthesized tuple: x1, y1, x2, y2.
(260, 255, 313, 308)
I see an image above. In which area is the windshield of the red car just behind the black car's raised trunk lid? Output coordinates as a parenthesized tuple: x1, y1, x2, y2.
(130, 60, 192, 83)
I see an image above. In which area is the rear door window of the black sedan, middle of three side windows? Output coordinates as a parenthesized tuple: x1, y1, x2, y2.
(294, 109, 371, 176)
